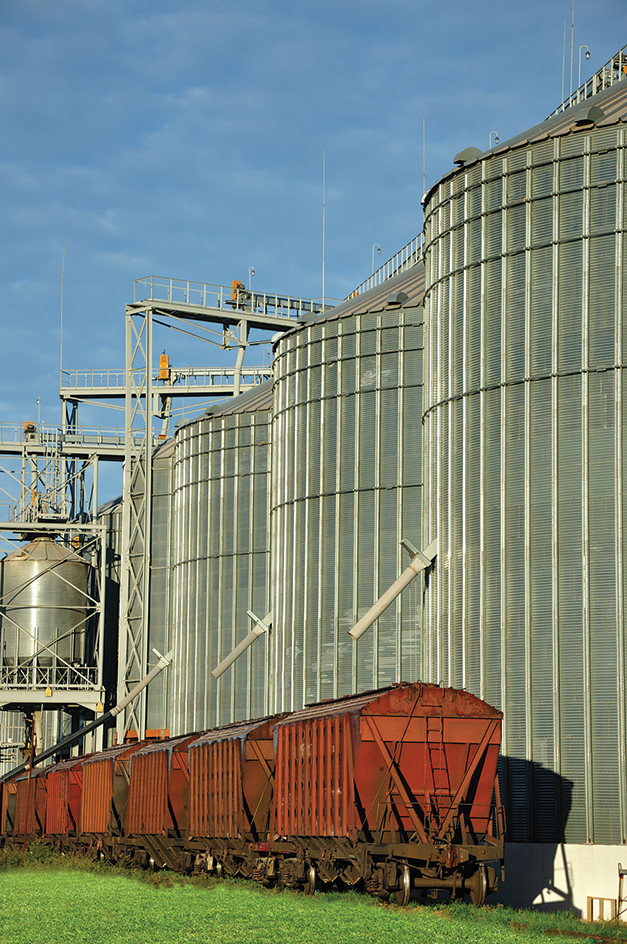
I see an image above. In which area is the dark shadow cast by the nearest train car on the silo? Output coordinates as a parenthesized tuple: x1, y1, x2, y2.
(490, 757, 580, 914)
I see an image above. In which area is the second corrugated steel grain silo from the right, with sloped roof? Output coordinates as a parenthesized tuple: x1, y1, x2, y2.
(271, 264, 424, 711)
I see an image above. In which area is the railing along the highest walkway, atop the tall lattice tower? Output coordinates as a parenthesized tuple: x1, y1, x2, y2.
(133, 275, 331, 319)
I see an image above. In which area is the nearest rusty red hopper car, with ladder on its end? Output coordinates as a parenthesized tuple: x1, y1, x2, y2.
(271, 683, 504, 904)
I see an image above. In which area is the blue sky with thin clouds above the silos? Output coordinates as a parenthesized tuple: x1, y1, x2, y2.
(0, 0, 627, 436)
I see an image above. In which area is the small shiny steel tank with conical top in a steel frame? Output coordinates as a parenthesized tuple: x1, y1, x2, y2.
(0, 537, 90, 667)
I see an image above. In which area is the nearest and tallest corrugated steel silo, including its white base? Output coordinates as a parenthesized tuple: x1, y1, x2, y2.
(423, 82, 627, 907)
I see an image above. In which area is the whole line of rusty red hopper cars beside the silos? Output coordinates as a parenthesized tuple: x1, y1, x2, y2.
(1, 683, 505, 904)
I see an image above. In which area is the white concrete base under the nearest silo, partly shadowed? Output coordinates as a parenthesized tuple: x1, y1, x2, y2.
(488, 842, 627, 920)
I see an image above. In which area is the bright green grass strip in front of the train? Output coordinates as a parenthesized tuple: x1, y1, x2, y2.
(0, 858, 627, 944)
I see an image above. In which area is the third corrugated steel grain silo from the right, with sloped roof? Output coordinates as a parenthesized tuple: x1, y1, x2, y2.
(170, 381, 272, 734)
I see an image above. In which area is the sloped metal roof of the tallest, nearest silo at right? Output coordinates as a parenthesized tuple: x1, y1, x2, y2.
(423, 79, 627, 205)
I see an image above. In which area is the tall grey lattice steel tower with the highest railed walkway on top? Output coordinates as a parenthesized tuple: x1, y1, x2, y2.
(118, 276, 322, 741)
